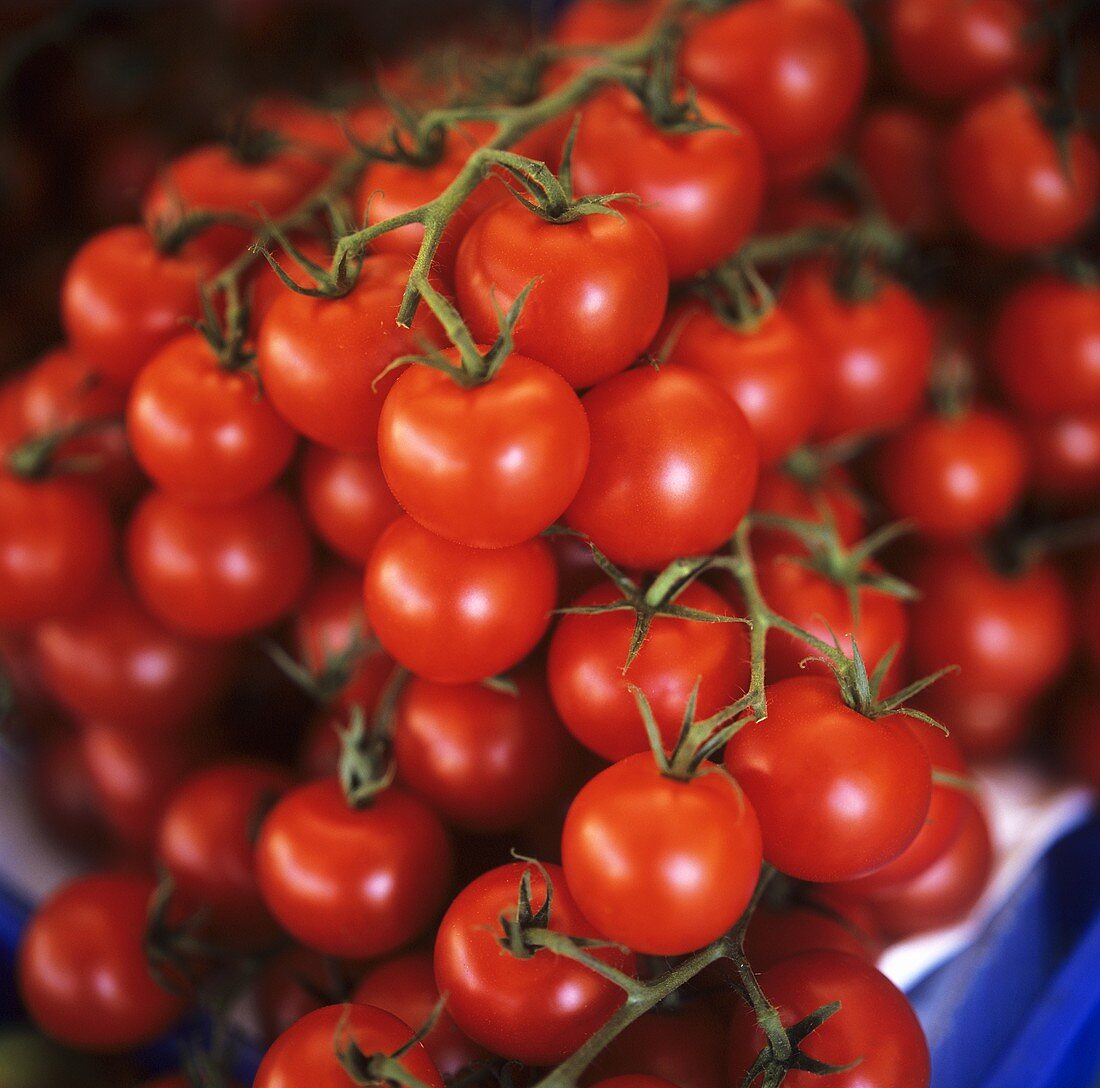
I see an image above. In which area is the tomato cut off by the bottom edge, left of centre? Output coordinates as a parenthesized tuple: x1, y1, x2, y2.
(252, 1004, 443, 1088)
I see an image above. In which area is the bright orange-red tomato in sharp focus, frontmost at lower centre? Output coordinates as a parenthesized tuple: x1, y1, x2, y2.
(561, 751, 760, 956)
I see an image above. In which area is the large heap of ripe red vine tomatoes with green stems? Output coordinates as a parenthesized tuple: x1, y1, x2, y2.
(0, 0, 1100, 1088)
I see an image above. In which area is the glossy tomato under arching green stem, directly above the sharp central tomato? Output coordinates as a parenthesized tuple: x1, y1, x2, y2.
(454, 200, 669, 388)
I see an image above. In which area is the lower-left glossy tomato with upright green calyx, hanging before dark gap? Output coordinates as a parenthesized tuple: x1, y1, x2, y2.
(255, 777, 451, 958)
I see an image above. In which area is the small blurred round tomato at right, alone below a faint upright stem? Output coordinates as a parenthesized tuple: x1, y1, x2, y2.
(878, 408, 1027, 539)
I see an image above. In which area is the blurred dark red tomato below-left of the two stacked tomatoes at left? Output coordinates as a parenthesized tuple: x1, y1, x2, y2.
(34, 578, 232, 736)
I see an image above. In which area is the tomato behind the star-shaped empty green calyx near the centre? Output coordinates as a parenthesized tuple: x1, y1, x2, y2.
(547, 581, 749, 759)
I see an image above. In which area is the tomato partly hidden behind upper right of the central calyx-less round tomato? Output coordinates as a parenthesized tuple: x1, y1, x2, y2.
(657, 301, 823, 468)
